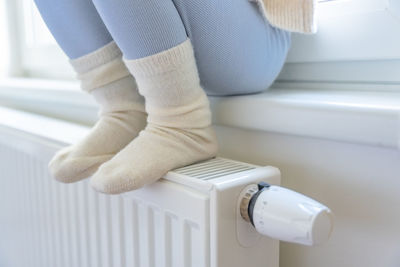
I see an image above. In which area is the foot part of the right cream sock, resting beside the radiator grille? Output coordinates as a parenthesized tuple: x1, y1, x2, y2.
(90, 124, 217, 194)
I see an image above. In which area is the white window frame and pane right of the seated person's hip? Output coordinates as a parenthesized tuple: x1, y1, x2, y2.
(277, 0, 400, 87)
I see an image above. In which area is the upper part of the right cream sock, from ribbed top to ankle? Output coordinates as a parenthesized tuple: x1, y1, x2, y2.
(125, 39, 211, 128)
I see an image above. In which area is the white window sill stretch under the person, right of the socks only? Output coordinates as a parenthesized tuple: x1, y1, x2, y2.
(211, 89, 400, 149)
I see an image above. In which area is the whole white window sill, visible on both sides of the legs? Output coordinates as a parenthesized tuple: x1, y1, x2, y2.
(0, 79, 400, 149)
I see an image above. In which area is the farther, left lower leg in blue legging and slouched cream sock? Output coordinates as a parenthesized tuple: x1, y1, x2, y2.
(35, 0, 146, 182)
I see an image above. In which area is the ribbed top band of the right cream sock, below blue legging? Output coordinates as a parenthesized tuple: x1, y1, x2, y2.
(124, 38, 194, 77)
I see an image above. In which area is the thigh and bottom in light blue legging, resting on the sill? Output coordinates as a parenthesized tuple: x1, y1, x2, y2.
(173, 0, 290, 95)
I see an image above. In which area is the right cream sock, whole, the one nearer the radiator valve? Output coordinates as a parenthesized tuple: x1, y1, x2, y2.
(91, 39, 217, 194)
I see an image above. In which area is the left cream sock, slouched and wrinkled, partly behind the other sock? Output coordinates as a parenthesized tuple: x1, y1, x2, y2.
(49, 42, 147, 183)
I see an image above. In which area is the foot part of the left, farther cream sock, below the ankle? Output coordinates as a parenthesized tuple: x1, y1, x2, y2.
(49, 111, 146, 183)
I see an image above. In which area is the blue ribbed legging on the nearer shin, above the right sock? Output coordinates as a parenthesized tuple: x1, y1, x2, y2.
(93, 0, 187, 59)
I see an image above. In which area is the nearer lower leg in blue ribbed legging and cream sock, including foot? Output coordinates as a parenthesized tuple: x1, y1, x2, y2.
(91, 0, 217, 193)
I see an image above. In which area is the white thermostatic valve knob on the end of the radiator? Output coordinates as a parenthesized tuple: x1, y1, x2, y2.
(240, 183, 333, 246)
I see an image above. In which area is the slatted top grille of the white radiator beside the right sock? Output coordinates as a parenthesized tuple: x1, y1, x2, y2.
(173, 158, 256, 180)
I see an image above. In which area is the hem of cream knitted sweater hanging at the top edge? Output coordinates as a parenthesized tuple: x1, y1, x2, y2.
(249, 0, 317, 33)
